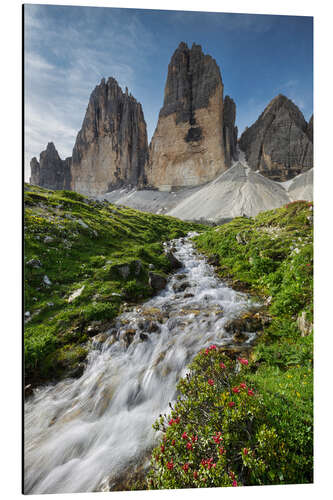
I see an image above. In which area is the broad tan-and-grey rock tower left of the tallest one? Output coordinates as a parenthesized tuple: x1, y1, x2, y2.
(71, 78, 148, 195)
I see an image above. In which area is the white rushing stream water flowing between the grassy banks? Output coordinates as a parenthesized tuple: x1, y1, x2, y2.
(24, 234, 253, 493)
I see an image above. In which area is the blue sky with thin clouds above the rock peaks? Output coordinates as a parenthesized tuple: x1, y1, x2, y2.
(24, 5, 313, 179)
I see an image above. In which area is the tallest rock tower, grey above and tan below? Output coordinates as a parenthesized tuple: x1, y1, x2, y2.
(146, 42, 228, 190)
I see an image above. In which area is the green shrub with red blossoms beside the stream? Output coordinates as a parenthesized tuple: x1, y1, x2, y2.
(148, 345, 286, 489)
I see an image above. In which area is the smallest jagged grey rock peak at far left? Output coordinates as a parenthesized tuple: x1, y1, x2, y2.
(30, 142, 71, 189)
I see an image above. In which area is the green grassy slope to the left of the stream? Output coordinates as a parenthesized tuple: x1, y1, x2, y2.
(24, 184, 198, 383)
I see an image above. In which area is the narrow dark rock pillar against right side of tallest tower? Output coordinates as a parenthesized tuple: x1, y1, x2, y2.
(223, 95, 238, 166)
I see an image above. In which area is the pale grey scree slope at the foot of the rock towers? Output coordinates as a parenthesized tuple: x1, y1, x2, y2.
(100, 160, 313, 223)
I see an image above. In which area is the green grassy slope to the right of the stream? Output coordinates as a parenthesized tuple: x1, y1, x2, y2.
(196, 201, 313, 483)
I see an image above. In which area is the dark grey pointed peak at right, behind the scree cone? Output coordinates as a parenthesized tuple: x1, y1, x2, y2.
(239, 94, 313, 181)
